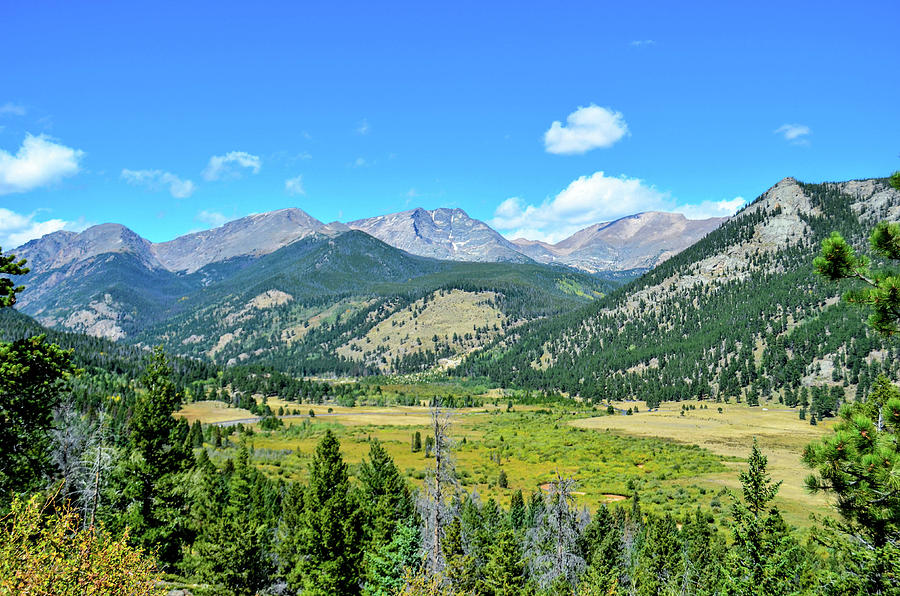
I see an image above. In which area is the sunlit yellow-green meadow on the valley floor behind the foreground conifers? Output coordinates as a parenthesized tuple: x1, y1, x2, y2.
(179, 387, 829, 527)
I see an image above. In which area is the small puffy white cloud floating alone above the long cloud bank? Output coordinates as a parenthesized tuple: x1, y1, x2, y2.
(544, 104, 628, 154)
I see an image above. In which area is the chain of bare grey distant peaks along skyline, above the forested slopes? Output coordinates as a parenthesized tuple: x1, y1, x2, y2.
(15, 208, 725, 273)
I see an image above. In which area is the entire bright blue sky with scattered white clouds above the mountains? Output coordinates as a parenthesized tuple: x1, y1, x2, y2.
(0, 0, 900, 248)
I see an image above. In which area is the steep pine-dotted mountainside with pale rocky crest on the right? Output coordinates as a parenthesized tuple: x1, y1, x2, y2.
(457, 178, 900, 410)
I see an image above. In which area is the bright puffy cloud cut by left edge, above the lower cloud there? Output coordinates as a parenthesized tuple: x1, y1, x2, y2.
(0, 134, 84, 195)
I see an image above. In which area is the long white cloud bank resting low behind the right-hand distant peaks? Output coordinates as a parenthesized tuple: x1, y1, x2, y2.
(488, 172, 745, 243)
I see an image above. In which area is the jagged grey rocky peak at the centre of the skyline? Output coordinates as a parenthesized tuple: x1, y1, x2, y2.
(347, 209, 531, 263)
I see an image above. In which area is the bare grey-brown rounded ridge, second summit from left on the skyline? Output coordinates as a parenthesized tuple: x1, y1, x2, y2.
(152, 209, 328, 273)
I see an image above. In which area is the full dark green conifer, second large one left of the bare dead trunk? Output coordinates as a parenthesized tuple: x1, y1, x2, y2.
(287, 430, 362, 596)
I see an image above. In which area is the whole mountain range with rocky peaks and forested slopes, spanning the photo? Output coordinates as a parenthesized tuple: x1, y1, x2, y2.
(8, 178, 900, 401)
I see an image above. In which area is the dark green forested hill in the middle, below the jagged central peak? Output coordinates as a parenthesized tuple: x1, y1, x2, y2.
(135, 231, 613, 374)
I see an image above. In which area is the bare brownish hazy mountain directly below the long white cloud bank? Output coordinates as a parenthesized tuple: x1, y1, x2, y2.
(513, 211, 727, 272)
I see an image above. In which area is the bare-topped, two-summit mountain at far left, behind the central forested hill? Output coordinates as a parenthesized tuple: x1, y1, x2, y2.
(12, 209, 332, 340)
